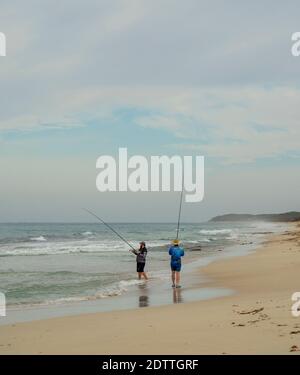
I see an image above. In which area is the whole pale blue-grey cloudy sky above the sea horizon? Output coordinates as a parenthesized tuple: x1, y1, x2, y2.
(0, 0, 300, 222)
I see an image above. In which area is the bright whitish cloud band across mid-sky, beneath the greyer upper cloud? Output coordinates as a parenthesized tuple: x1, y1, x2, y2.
(0, 86, 300, 163)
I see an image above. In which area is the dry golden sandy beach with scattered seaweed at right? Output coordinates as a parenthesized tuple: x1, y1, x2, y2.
(0, 224, 300, 354)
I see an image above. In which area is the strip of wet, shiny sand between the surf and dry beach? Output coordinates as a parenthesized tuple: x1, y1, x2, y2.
(0, 233, 265, 326)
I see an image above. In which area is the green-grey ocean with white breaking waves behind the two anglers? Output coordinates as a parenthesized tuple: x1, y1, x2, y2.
(0, 222, 283, 308)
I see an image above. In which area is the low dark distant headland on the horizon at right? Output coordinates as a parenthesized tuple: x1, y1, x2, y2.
(210, 211, 300, 222)
